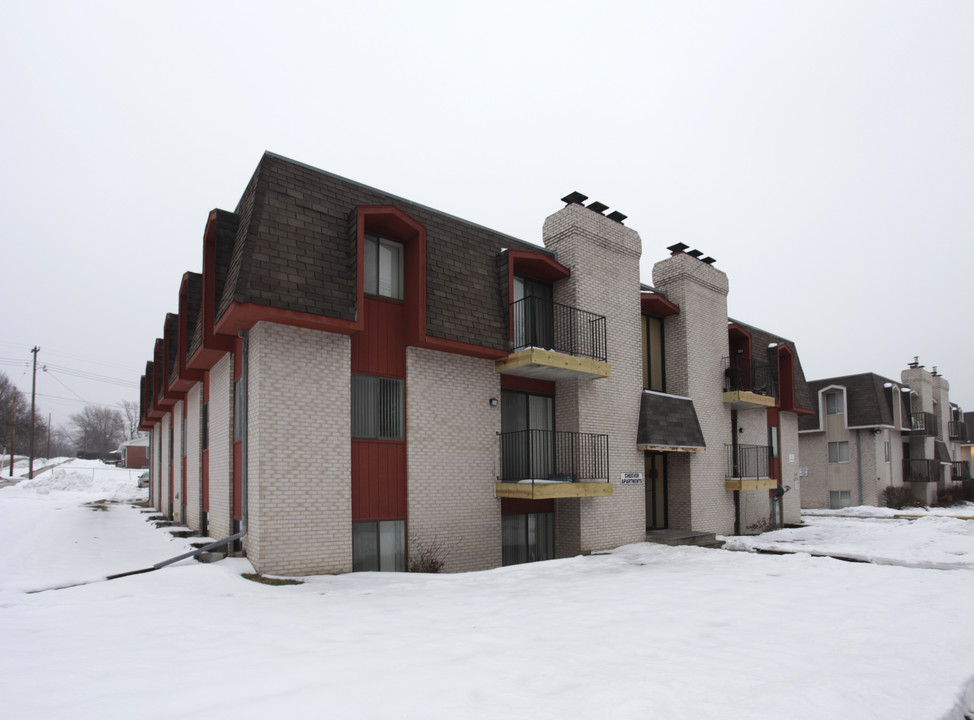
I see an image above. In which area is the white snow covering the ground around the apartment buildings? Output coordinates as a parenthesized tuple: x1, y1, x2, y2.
(0, 461, 974, 720)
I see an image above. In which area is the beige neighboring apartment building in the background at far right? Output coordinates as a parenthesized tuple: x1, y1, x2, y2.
(800, 362, 971, 508)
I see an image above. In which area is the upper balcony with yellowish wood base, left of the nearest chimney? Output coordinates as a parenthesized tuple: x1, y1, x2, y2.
(494, 297, 611, 381)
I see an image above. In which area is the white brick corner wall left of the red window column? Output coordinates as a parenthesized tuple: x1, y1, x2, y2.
(246, 322, 352, 575)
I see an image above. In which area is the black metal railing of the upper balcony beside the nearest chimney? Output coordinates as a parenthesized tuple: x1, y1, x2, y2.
(511, 297, 606, 362)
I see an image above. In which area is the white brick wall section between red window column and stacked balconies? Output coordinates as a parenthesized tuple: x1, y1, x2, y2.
(406, 347, 501, 572)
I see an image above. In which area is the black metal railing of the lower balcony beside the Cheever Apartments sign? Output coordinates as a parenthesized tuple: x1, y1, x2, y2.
(499, 430, 609, 482)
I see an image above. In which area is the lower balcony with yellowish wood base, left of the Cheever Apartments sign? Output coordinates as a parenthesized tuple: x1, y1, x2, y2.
(494, 430, 612, 500)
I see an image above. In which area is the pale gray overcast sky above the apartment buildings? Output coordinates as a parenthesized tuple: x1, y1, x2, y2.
(0, 0, 974, 425)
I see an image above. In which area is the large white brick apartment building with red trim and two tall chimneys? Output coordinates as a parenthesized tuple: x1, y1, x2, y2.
(140, 153, 808, 574)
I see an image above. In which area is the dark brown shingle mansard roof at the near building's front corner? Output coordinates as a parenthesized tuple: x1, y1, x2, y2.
(216, 153, 546, 349)
